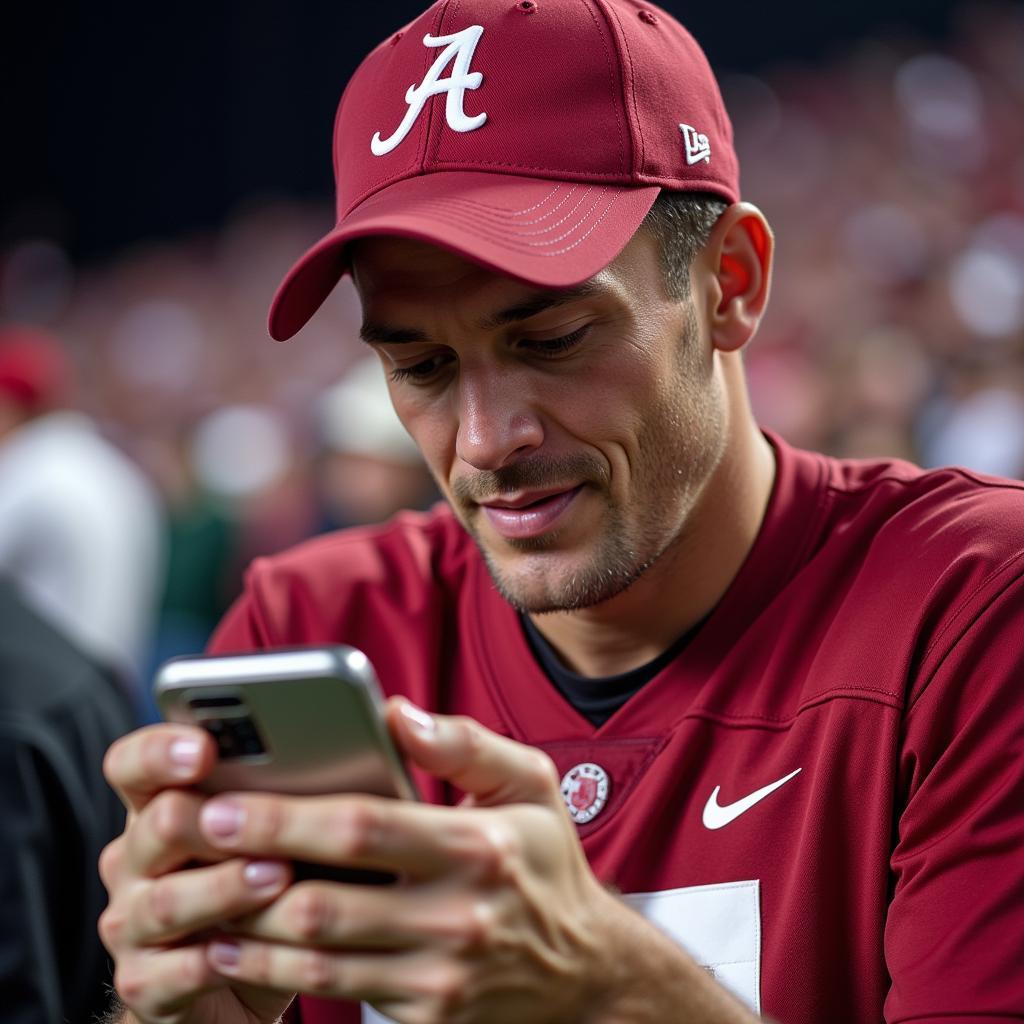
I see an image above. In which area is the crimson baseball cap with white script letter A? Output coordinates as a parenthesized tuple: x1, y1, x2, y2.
(269, 0, 739, 341)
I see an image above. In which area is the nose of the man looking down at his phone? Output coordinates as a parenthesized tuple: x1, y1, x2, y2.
(456, 372, 544, 470)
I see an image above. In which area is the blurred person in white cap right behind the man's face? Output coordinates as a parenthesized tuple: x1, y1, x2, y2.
(317, 355, 439, 529)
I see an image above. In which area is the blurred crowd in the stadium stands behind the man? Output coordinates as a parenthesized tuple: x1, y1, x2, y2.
(0, 3, 1024, 717)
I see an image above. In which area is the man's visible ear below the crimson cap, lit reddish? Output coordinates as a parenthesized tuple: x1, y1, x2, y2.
(695, 203, 775, 352)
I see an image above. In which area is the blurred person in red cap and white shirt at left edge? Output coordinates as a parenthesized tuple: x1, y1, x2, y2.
(0, 327, 164, 696)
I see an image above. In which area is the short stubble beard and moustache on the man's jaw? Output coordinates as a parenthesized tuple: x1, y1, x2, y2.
(455, 307, 725, 614)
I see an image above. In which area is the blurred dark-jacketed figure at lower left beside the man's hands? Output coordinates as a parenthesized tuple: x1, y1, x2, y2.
(0, 577, 133, 1024)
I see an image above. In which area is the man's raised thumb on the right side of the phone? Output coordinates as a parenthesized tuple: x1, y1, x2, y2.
(387, 697, 561, 807)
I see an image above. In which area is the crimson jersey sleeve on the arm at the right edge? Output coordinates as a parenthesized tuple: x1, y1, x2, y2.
(885, 565, 1024, 1024)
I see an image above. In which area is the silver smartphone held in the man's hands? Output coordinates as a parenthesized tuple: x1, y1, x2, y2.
(154, 646, 418, 884)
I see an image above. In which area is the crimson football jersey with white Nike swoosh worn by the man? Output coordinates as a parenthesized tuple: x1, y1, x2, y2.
(207, 437, 1024, 1024)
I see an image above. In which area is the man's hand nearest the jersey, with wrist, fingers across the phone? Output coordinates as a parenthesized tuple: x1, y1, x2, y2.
(195, 699, 753, 1024)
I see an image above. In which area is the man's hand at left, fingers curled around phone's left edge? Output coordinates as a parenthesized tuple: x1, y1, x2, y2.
(99, 725, 291, 1024)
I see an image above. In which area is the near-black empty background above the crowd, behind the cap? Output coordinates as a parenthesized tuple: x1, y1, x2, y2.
(0, 0, 954, 262)
